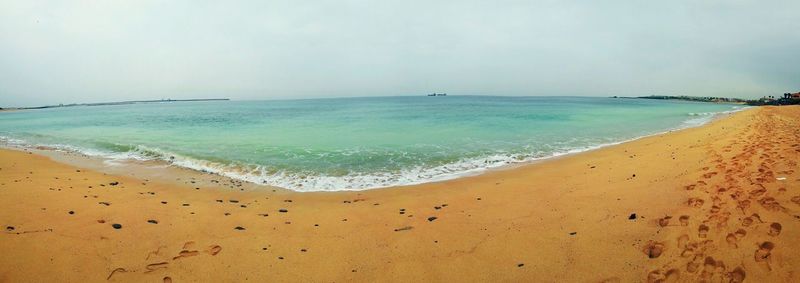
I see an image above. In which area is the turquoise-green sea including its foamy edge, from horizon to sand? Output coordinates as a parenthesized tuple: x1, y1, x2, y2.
(0, 96, 737, 191)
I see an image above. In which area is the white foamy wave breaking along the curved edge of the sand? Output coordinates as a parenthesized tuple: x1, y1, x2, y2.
(0, 107, 748, 192)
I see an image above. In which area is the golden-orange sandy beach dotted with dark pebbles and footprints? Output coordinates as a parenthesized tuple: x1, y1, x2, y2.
(0, 107, 800, 282)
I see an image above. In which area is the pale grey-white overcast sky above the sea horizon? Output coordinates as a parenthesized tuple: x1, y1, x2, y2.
(0, 0, 800, 107)
